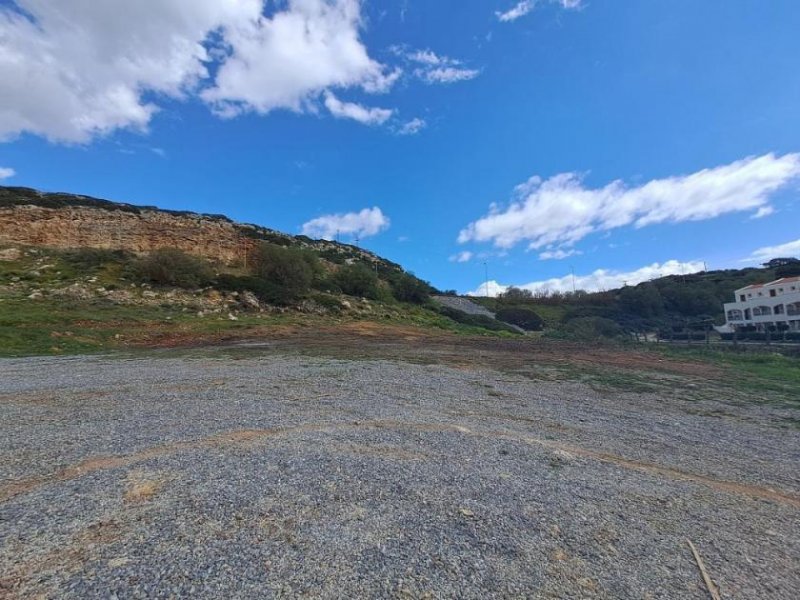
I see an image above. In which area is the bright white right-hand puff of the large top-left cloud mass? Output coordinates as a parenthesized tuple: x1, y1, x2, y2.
(201, 0, 400, 115)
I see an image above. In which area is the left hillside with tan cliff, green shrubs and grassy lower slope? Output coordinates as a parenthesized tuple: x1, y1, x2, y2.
(0, 187, 514, 356)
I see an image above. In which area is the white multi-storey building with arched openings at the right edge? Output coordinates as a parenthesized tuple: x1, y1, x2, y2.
(719, 277, 800, 331)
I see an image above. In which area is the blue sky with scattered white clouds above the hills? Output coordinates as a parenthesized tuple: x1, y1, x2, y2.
(0, 0, 800, 292)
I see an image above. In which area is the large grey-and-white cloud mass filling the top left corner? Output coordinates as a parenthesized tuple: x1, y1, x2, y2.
(0, 0, 400, 143)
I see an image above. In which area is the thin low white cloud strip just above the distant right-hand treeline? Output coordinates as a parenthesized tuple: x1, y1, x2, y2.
(467, 260, 704, 297)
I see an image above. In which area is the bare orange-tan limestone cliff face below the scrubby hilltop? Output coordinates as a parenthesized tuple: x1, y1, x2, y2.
(0, 205, 257, 263)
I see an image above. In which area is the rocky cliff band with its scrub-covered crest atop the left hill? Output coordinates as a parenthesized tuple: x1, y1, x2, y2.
(0, 186, 400, 270)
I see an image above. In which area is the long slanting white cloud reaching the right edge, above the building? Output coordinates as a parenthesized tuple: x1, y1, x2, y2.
(458, 154, 800, 249)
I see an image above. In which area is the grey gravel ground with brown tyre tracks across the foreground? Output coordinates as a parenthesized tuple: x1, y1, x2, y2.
(0, 354, 800, 600)
